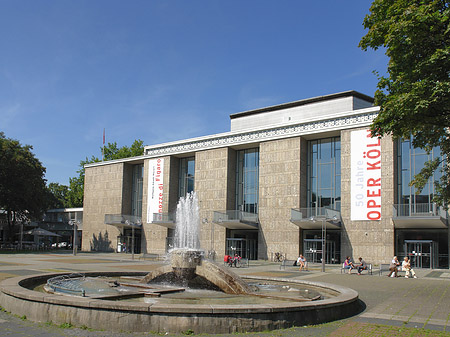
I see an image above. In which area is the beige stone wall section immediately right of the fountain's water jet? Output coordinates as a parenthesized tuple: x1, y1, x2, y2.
(195, 148, 230, 258)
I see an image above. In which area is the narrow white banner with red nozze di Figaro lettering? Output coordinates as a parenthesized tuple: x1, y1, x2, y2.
(147, 158, 164, 223)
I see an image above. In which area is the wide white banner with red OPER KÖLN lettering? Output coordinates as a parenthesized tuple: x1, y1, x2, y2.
(350, 130, 381, 220)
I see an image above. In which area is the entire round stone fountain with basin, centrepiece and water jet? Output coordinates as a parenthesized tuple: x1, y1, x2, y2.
(0, 193, 360, 333)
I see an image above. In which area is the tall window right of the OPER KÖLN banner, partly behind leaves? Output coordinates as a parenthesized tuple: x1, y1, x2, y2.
(397, 139, 442, 209)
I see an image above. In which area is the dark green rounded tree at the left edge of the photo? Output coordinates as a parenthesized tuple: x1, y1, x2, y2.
(0, 132, 48, 240)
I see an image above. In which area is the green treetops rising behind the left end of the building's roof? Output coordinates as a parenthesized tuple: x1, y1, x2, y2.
(67, 139, 144, 207)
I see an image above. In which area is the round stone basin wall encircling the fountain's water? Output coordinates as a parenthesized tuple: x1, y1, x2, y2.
(0, 272, 360, 334)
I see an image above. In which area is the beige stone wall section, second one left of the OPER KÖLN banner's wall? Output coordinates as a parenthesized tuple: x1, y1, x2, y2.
(258, 137, 306, 259)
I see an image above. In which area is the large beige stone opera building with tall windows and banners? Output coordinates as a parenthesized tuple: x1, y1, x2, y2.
(82, 91, 449, 268)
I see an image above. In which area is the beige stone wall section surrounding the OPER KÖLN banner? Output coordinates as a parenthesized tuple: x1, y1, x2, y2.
(341, 130, 395, 264)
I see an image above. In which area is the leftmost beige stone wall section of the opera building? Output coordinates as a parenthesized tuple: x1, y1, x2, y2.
(81, 163, 124, 251)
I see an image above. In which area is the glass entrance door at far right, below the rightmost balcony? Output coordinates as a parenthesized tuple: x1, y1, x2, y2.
(404, 240, 439, 268)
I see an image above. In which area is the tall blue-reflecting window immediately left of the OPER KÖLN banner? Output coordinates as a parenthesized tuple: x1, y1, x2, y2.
(308, 137, 341, 210)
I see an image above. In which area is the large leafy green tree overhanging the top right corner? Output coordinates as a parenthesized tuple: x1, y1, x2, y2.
(359, 0, 450, 204)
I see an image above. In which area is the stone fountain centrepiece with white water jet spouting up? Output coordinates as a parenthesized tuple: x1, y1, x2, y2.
(142, 192, 251, 294)
